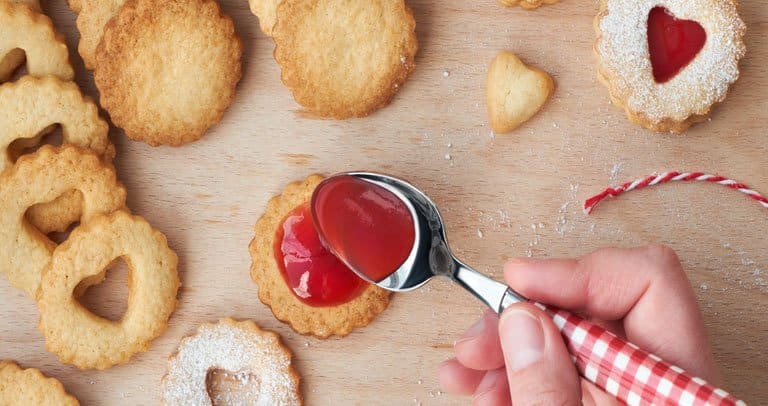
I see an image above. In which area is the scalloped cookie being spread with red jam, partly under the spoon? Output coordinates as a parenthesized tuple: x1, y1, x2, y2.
(249, 175, 390, 338)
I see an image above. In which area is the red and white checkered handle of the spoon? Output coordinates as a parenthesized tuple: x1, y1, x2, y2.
(536, 303, 745, 406)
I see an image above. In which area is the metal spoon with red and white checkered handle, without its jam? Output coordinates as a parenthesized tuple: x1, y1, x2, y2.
(313, 172, 744, 405)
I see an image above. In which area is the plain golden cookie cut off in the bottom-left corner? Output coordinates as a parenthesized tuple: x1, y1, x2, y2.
(0, 360, 80, 406)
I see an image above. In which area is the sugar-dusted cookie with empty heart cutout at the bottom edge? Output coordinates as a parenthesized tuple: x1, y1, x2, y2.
(161, 318, 302, 406)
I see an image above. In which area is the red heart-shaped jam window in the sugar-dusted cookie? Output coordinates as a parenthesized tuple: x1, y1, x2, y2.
(648, 7, 707, 83)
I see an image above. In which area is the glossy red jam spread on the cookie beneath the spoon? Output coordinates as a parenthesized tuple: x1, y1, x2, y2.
(274, 204, 367, 307)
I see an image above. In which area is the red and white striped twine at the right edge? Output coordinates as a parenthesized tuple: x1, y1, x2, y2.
(584, 172, 768, 214)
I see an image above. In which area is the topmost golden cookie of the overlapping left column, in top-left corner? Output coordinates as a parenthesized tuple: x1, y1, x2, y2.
(0, 1, 75, 82)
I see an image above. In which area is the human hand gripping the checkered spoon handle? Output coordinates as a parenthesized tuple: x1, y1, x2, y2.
(439, 246, 720, 406)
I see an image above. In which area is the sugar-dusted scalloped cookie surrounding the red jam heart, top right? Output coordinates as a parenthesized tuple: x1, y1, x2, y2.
(594, 0, 746, 133)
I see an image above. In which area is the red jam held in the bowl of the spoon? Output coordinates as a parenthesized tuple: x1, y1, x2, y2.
(312, 176, 416, 282)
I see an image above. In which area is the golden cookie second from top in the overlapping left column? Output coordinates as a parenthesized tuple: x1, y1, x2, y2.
(0, 76, 115, 234)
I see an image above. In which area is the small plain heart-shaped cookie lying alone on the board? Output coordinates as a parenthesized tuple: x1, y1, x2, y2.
(485, 51, 555, 133)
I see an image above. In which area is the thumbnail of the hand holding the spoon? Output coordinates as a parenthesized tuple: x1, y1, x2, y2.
(499, 309, 544, 371)
